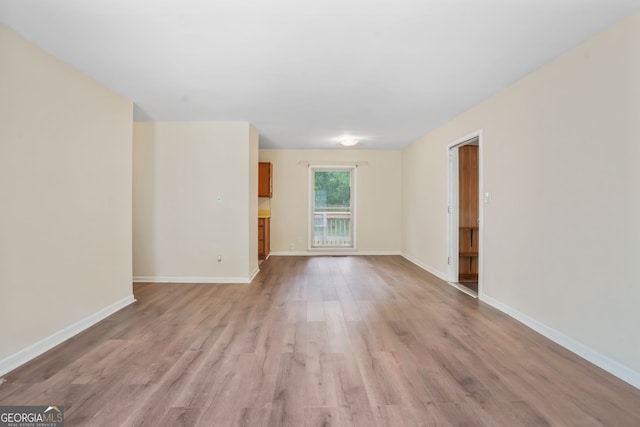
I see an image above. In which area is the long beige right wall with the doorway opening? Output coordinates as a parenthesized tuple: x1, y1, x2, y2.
(403, 14, 640, 378)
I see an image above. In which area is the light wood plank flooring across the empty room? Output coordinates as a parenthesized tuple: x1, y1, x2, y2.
(0, 256, 640, 427)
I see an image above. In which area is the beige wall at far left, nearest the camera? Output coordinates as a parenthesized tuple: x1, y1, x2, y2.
(0, 25, 132, 364)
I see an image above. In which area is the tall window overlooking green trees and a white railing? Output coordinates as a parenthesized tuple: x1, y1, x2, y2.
(309, 166, 356, 249)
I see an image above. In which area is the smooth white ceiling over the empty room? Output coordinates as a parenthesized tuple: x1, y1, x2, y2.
(0, 0, 640, 149)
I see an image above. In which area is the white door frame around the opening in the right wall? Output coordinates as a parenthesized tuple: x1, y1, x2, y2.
(446, 129, 484, 298)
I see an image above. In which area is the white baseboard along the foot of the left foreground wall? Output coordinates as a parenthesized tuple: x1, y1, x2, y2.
(0, 294, 135, 375)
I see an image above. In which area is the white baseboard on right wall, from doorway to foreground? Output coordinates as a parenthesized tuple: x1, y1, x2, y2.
(479, 293, 640, 389)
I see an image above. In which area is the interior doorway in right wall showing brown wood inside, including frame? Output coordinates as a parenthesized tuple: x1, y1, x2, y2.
(447, 132, 482, 297)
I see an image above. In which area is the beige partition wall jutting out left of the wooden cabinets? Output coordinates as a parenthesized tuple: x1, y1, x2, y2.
(133, 122, 258, 282)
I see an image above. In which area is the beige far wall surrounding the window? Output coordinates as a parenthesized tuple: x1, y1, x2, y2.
(260, 150, 402, 253)
